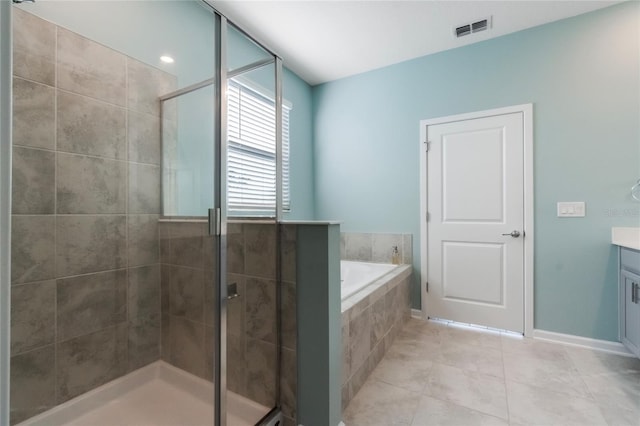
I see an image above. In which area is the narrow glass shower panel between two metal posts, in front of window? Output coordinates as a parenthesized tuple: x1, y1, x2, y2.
(221, 21, 281, 425)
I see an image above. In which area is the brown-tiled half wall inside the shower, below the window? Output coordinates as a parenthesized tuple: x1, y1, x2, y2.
(160, 220, 297, 425)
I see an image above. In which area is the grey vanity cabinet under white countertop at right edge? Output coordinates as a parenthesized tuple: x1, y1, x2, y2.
(620, 247, 640, 357)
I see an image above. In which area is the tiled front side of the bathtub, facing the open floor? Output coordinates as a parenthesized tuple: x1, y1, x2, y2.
(342, 265, 412, 410)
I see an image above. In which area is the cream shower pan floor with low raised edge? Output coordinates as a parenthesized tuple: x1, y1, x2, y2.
(17, 361, 269, 426)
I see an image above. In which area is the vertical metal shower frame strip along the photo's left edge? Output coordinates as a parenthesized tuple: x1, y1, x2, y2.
(0, 1, 13, 425)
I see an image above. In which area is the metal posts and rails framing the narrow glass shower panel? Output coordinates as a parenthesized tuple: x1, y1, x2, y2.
(159, 4, 284, 426)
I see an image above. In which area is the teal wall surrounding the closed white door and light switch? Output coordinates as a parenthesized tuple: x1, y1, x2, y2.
(313, 2, 640, 341)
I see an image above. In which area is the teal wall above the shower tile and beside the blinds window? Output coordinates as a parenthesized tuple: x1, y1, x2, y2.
(20, 0, 315, 220)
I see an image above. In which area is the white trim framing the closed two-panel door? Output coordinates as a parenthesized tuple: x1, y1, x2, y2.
(419, 104, 535, 337)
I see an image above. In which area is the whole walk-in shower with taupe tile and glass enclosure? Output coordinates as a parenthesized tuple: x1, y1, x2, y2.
(0, 0, 284, 425)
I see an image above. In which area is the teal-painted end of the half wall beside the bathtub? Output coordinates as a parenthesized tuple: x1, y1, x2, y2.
(296, 223, 342, 426)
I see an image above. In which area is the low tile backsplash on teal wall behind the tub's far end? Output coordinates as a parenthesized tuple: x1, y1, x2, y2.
(340, 232, 413, 265)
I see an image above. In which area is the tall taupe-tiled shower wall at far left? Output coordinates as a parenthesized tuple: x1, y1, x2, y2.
(11, 7, 176, 423)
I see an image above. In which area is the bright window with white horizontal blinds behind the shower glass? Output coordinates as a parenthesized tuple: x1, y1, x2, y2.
(227, 80, 291, 213)
